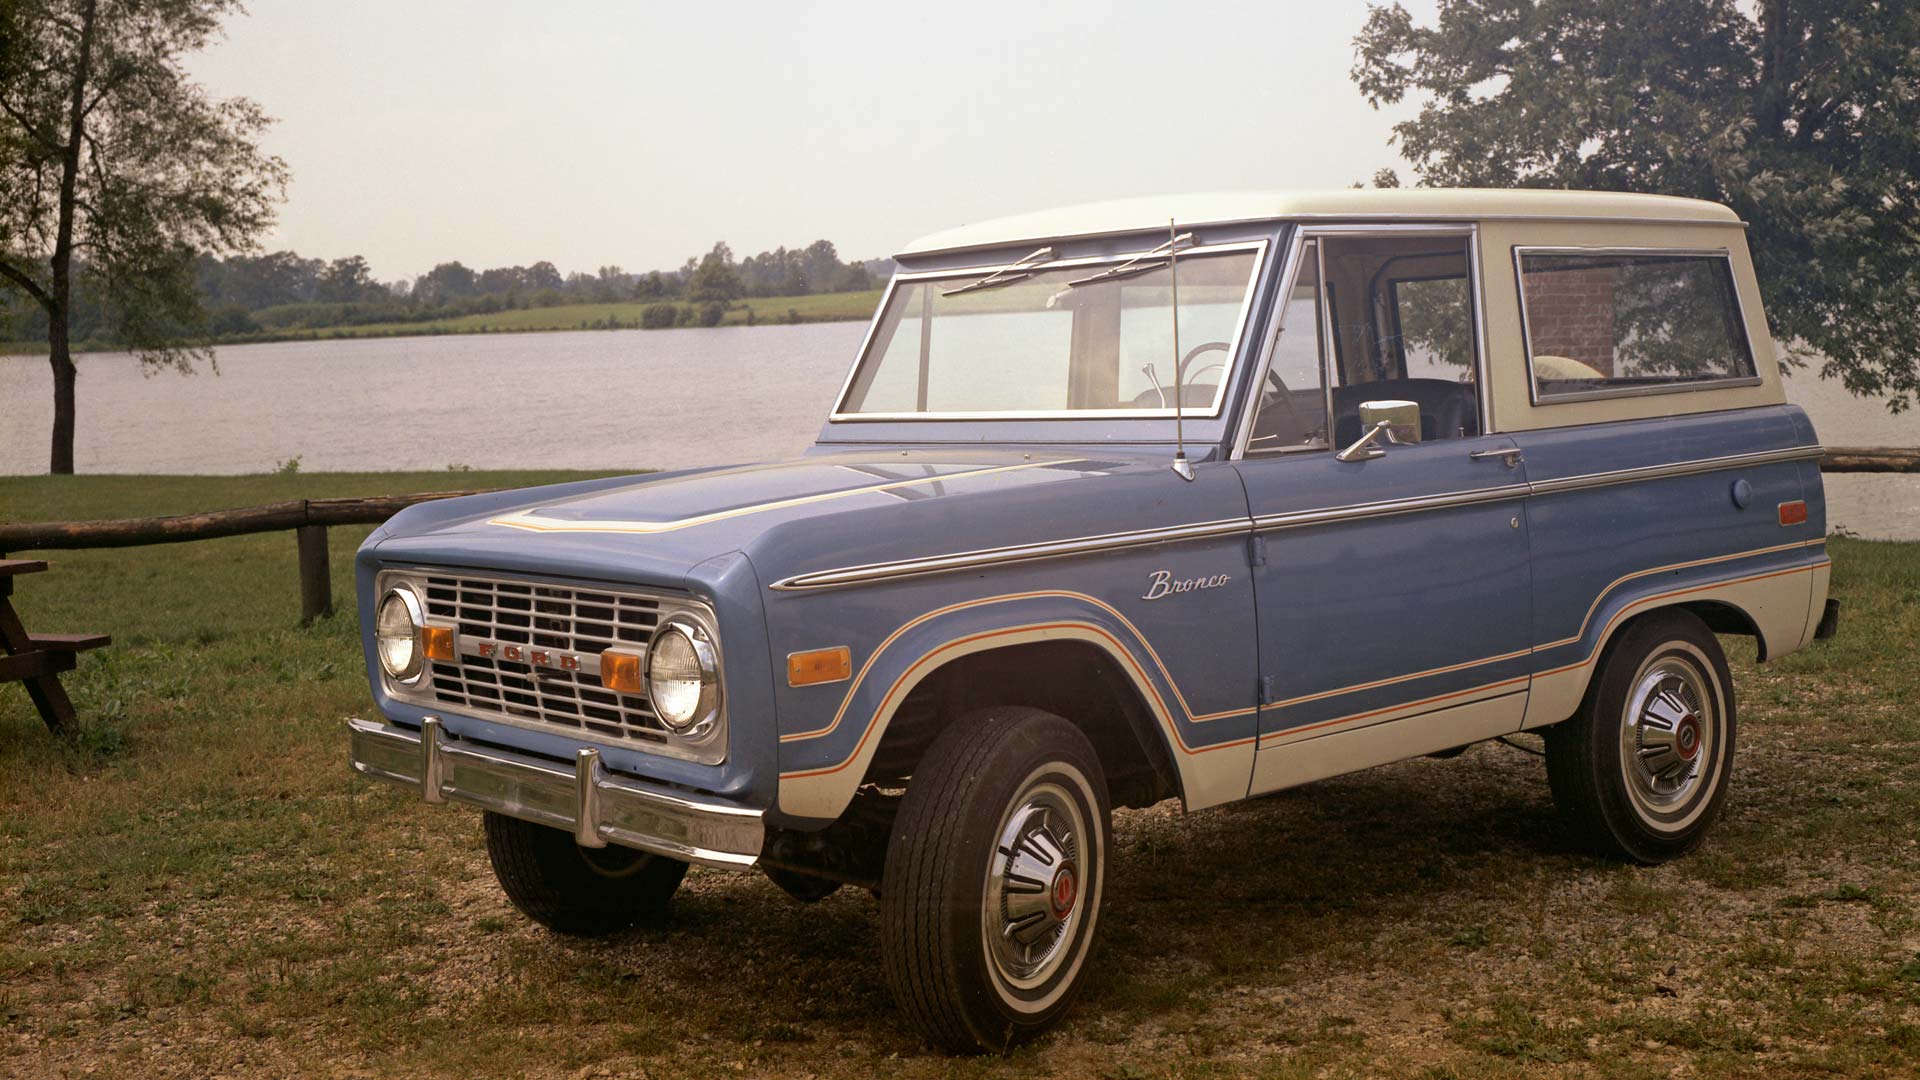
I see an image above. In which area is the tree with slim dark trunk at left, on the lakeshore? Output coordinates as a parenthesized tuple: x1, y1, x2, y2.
(0, 0, 286, 473)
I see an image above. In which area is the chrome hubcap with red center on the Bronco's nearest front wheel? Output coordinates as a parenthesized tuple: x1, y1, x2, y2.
(983, 782, 1087, 990)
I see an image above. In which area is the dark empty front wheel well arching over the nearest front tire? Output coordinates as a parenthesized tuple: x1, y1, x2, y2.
(864, 642, 1179, 807)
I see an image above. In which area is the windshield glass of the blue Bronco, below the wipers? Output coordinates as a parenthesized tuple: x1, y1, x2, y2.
(837, 246, 1260, 419)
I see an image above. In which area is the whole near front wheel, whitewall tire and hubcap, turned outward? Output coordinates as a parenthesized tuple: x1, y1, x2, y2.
(879, 709, 1112, 1053)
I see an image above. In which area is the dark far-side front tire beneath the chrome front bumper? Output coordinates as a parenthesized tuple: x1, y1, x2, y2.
(486, 811, 687, 938)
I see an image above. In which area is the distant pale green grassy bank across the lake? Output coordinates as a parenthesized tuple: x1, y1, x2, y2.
(0, 288, 881, 356)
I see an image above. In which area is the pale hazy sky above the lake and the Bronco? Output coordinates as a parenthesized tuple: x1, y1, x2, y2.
(188, 0, 1432, 281)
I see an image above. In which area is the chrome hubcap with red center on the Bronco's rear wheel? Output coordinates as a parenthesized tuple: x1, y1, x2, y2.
(1620, 657, 1718, 813)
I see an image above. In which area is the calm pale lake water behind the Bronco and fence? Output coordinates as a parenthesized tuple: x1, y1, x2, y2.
(0, 323, 1920, 540)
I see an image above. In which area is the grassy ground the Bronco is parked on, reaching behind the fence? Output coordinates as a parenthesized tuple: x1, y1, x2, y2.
(0, 473, 1920, 1080)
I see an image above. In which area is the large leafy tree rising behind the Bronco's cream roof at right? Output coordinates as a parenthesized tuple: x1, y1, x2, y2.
(1352, 0, 1920, 411)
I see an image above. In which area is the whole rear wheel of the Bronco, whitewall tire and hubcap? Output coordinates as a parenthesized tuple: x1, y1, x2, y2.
(1546, 609, 1736, 865)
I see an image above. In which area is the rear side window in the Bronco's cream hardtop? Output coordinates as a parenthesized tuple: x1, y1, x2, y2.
(1517, 248, 1755, 402)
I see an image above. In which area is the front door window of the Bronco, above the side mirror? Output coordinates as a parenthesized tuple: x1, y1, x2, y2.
(1248, 234, 1480, 452)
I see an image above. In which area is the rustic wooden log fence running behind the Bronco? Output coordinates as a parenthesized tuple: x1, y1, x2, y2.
(0, 446, 1920, 623)
